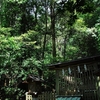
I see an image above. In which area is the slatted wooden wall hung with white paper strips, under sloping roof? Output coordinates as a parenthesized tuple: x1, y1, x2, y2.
(55, 64, 99, 100)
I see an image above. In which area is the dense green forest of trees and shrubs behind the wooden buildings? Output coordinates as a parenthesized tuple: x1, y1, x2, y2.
(0, 0, 100, 100)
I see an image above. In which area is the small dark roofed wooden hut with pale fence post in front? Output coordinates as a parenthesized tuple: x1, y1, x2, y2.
(18, 75, 43, 100)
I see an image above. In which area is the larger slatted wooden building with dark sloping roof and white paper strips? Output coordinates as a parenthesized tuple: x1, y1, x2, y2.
(49, 55, 100, 100)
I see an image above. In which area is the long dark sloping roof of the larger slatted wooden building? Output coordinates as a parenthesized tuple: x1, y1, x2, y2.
(49, 55, 100, 70)
